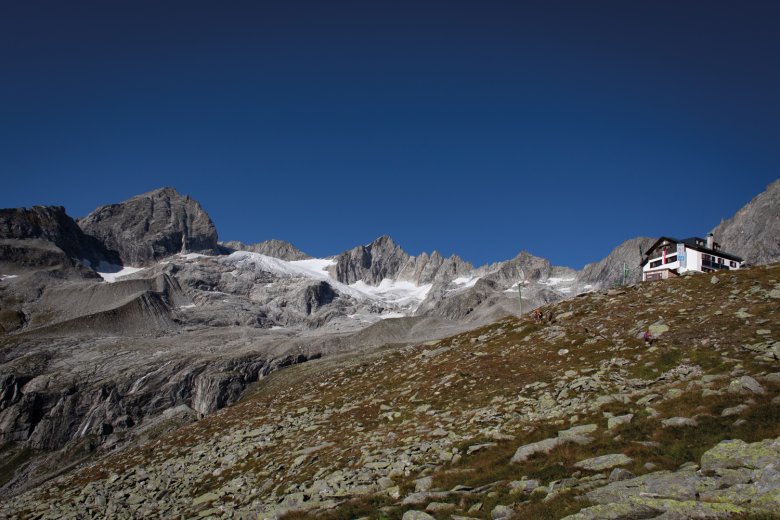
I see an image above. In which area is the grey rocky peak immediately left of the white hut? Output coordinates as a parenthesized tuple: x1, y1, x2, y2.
(577, 237, 655, 292)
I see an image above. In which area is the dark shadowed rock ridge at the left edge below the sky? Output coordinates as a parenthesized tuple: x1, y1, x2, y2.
(0, 206, 119, 268)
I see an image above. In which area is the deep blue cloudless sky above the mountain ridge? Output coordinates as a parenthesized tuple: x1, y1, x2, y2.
(0, 0, 780, 267)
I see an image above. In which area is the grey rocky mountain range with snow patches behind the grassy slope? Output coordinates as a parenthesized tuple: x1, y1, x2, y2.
(0, 183, 780, 500)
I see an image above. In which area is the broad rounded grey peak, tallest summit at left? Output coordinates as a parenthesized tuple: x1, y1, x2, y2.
(78, 188, 219, 265)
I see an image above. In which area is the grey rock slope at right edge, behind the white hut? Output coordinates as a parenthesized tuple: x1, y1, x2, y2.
(712, 179, 780, 265)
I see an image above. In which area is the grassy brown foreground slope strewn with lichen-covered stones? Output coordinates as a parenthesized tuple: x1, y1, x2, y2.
(0, 264, 780, 520)
